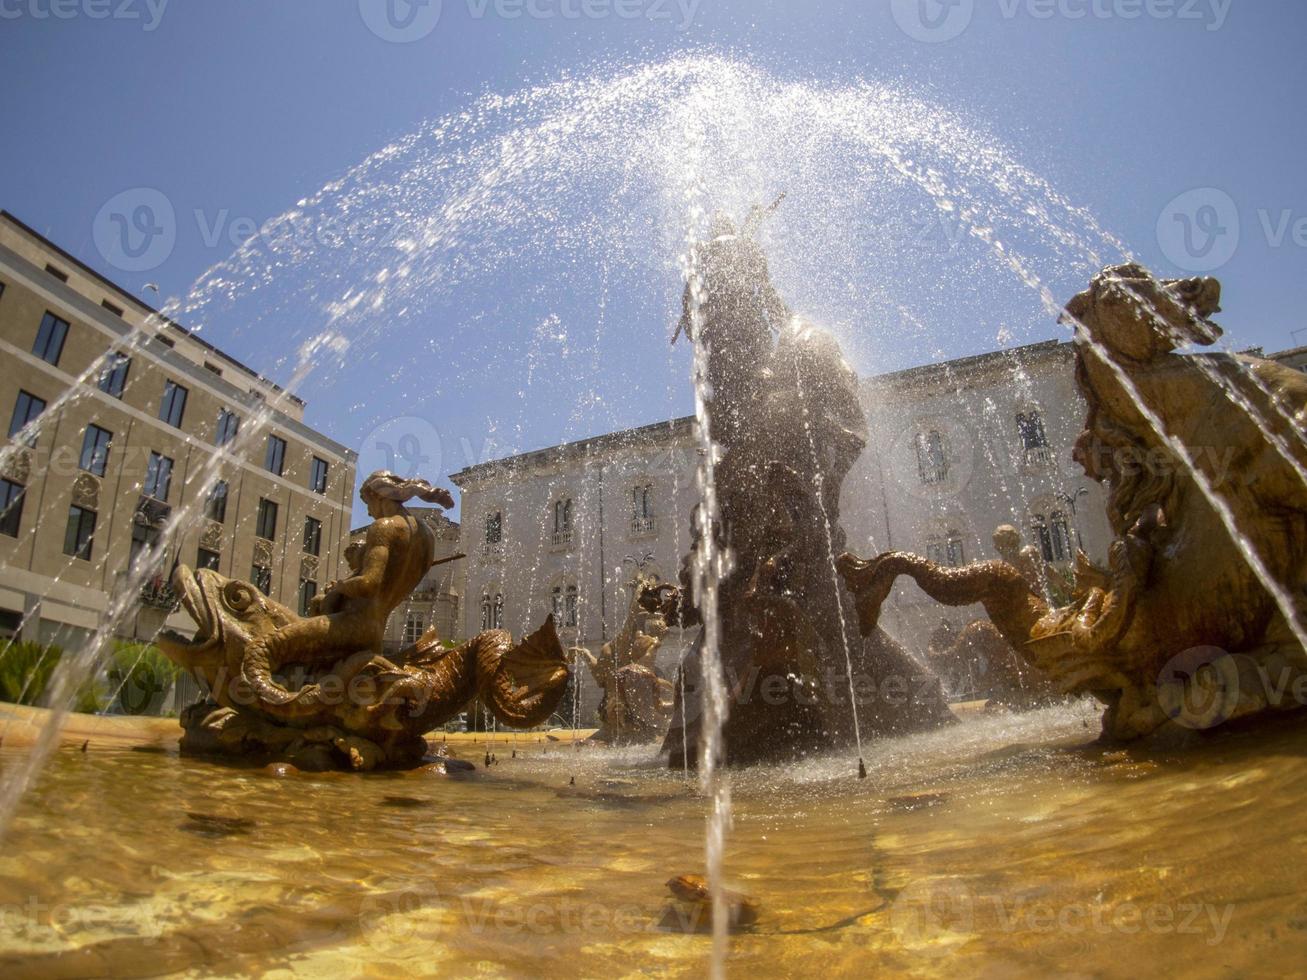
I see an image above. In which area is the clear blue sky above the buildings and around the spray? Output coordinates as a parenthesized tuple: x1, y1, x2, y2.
(0, 0, 1307, 530)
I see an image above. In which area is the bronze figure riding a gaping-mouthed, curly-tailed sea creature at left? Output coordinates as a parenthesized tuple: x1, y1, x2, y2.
(158, 472, 569, 768)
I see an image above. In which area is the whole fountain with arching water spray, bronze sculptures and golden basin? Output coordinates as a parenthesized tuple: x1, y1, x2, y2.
(0, 54, 1307, 977)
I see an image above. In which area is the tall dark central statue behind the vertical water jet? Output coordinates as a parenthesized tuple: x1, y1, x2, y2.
(664, 203, 953, 766)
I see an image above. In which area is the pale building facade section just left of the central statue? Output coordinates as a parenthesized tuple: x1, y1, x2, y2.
(454, 418, 698, 707)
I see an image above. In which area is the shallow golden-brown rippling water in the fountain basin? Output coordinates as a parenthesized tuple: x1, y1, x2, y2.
(0, 706, 1307, 977)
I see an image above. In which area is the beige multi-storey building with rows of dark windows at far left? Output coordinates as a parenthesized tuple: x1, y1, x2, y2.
(0, 212, 357, 645)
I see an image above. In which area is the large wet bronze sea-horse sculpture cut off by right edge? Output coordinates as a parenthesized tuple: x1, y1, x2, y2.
(839, 265, 1307, 740)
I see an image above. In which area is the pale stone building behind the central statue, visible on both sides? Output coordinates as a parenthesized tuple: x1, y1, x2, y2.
(454, 341, 1202, 710)
